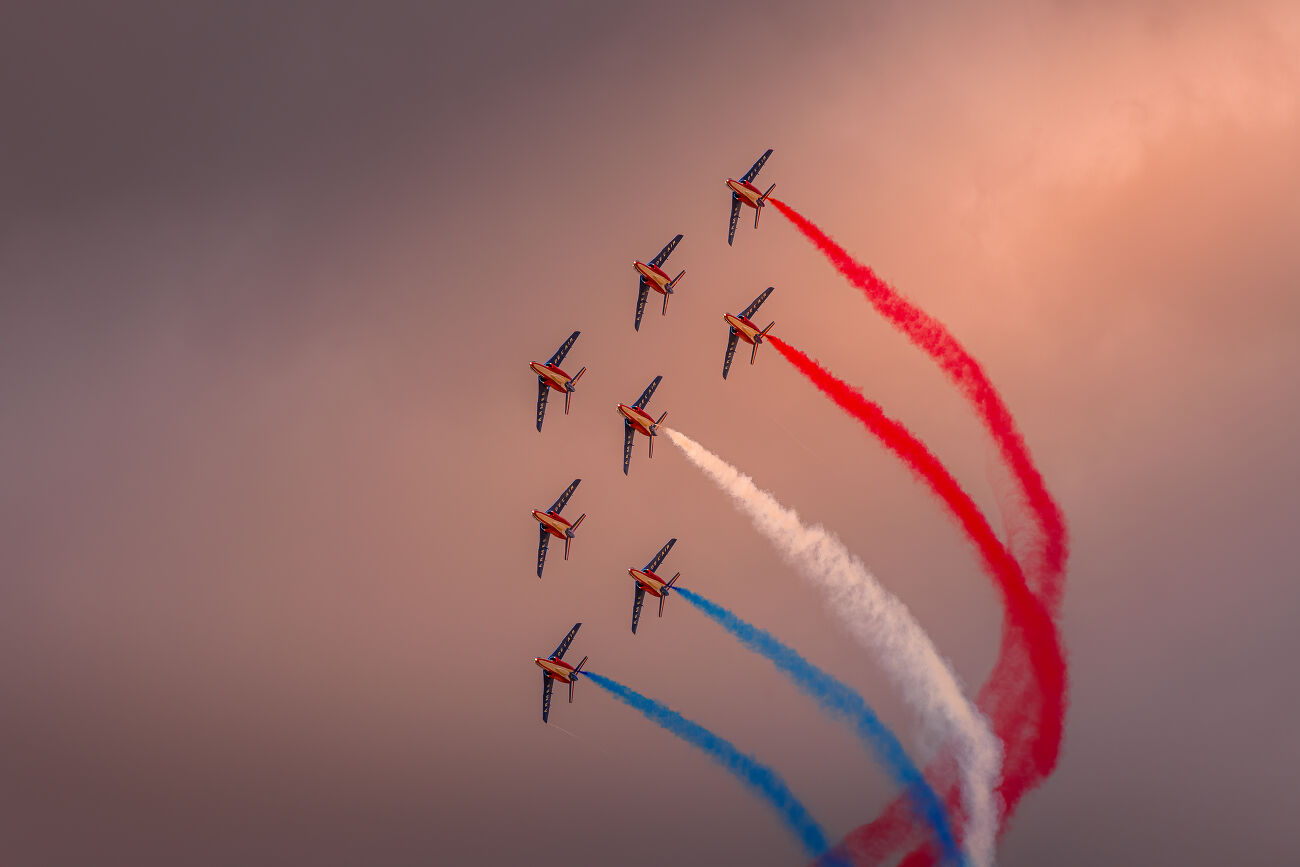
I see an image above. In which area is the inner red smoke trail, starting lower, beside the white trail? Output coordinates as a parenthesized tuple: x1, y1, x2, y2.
(767, 335, 1066, 864)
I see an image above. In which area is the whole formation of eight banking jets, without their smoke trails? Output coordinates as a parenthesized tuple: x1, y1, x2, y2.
(529, 148, 776, 723)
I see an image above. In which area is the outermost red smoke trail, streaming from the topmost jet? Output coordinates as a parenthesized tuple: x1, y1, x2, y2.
(767, 198, 1069, 616)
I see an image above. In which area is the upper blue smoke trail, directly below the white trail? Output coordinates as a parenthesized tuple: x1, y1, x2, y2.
(673, 585, 966, 864)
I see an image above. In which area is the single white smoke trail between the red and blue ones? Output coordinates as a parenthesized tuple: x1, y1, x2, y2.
(664, 428, 1001, 866)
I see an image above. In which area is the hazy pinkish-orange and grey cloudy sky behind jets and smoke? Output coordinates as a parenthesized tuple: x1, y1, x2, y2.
(0, 1, 1300, 864)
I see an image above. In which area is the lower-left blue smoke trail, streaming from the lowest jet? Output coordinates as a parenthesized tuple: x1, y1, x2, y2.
(582, 671, 827, 857)
